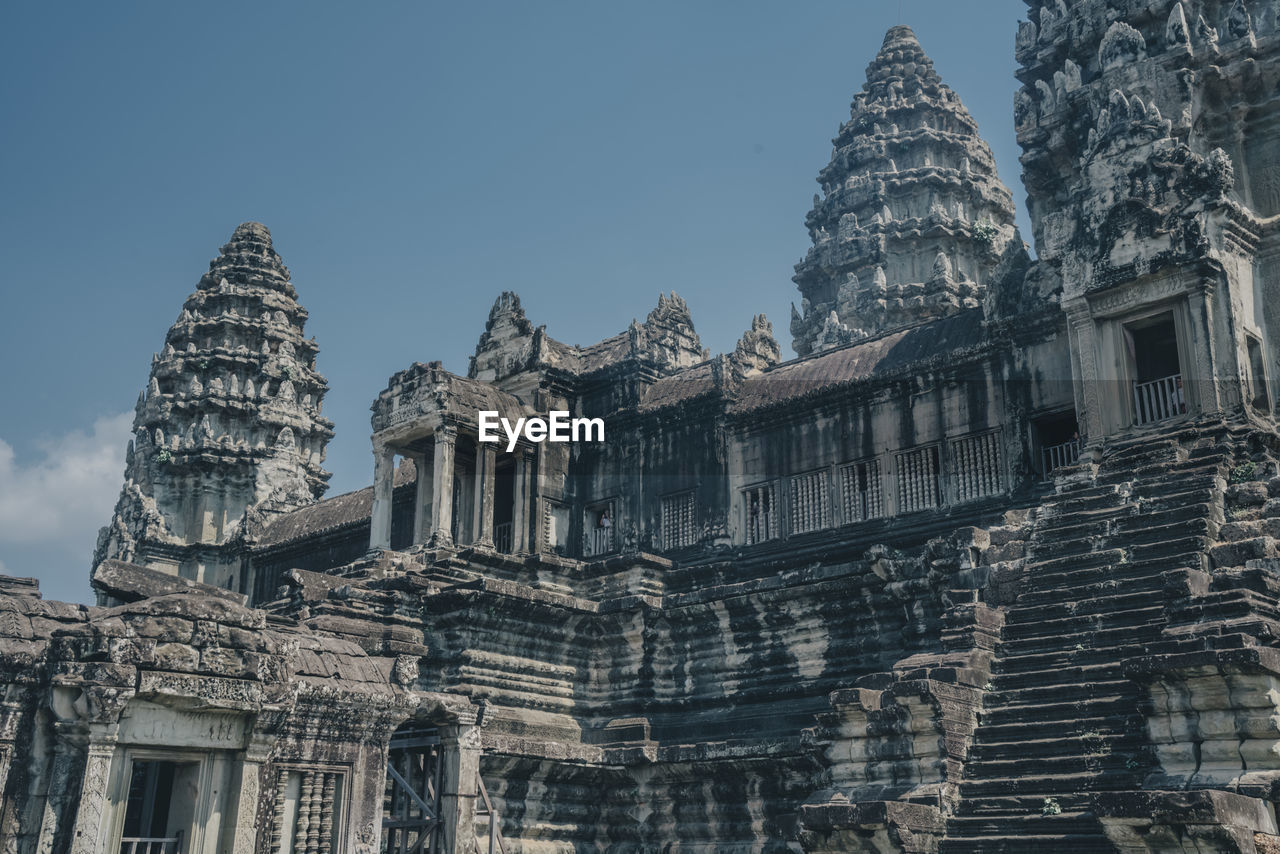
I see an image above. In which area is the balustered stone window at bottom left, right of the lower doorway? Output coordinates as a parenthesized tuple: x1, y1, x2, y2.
(269, 768, 344, 854)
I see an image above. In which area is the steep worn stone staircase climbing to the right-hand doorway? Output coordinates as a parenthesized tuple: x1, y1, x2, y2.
(941, 437, 1230, 854)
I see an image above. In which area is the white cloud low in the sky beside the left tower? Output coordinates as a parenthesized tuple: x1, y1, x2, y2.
(0, 412, 133, 550)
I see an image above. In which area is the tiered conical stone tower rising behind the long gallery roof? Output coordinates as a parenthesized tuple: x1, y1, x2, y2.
(791, 27, 1018, 356)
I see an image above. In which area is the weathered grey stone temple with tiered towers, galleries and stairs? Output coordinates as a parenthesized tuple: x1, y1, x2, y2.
(0, 0, 1280, 854)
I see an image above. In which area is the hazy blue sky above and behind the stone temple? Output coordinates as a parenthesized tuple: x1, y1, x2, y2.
(0, 0, 1029, 600)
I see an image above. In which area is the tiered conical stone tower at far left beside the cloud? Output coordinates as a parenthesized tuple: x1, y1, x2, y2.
(93, 223, 333, 589)
